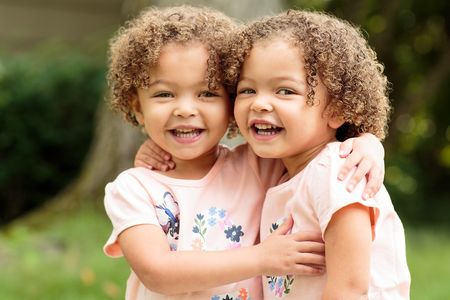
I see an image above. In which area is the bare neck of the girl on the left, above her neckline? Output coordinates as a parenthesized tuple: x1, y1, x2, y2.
(160, 146, 219, 180)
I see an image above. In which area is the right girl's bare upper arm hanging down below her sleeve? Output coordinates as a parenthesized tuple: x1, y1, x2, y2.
(323, 204, 372, 300)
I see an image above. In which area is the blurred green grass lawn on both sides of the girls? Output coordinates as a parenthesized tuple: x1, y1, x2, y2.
(0, 205, 450, 300)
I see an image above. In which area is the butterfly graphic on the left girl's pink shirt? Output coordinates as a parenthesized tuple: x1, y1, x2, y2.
(155, 192, 180, 240)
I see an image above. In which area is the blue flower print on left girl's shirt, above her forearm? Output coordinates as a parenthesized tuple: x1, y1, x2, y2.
(191, 207, 244, 250)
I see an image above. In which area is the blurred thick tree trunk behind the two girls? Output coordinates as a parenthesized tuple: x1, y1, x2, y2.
(21, 0, 282, 226)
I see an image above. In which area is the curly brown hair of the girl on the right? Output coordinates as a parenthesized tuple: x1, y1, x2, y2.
(224, 10, 391, 140)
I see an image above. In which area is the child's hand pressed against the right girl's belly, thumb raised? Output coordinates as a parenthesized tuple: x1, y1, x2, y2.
(257, 218, 325, 275)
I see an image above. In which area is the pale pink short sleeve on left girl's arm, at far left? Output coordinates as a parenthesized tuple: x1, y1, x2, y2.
(103, 171, 160, 257)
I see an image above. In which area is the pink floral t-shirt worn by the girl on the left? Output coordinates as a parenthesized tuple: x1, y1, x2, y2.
(104, 145, 283, 300)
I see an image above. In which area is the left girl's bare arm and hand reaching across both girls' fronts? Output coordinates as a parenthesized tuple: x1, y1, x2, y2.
(119, 217, 324, 295)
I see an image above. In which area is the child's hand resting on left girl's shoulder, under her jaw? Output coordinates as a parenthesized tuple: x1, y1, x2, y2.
(134, 139, 175, 171)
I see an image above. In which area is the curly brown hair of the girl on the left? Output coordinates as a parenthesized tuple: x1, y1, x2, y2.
(108, 5, 236, 125)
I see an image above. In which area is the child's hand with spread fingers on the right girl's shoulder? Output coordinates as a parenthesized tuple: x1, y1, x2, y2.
(338, 133, 384, 199)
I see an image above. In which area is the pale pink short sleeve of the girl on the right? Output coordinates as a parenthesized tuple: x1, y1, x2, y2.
(307, 143, 379, 239)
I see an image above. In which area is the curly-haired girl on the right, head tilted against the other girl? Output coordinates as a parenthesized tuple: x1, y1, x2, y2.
(226, 11, 410, 300)
